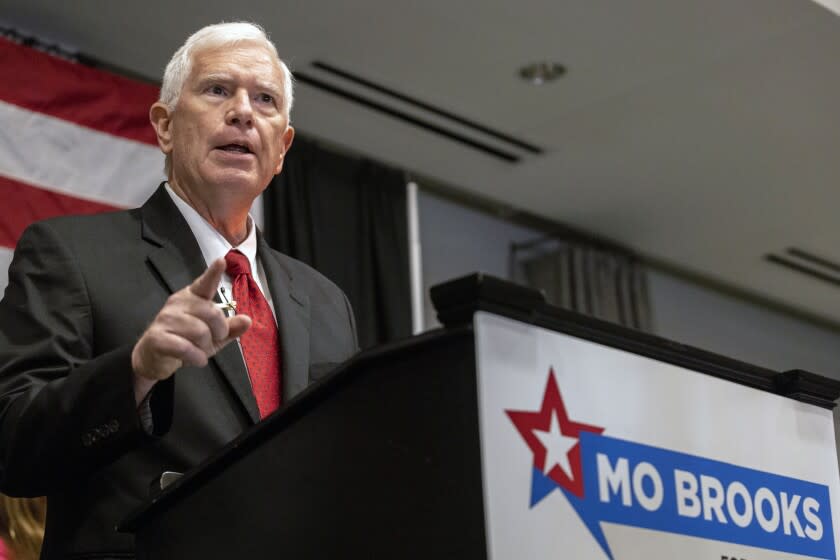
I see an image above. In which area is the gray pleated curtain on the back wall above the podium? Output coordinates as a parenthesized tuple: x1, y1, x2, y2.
(511, 240, 652, 332)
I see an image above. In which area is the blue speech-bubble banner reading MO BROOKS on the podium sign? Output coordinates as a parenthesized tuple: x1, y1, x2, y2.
(560, 432, 836, 560)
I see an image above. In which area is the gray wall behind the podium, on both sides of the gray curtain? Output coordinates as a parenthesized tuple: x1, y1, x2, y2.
(418, 191, 840, 379)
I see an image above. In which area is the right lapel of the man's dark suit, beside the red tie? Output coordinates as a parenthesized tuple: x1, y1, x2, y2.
(257, 234, 309, 403)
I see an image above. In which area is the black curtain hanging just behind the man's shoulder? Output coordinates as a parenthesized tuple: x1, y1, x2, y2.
(264, 136, 411, 348)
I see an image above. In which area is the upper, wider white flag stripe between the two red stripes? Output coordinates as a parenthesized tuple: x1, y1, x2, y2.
(0, 101, 164, 208)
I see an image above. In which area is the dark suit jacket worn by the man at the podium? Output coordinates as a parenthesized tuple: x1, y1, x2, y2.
(0, 188, 357, 558)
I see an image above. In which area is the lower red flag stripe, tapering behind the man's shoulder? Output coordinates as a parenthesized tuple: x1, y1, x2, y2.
(0, 175, 118, 247)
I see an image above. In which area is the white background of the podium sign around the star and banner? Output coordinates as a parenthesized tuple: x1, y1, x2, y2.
(474, 312, 840, 560)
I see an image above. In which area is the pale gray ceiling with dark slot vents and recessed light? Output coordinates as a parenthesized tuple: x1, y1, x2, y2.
(0, 0, 840, 324)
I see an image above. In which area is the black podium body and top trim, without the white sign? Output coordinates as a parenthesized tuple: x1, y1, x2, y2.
(120, 275, 840, 560)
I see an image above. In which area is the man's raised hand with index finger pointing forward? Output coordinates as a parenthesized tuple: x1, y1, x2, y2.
(131, 259, 251, 384)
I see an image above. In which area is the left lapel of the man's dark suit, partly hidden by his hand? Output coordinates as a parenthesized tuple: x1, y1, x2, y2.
(141, 185, 260, 422)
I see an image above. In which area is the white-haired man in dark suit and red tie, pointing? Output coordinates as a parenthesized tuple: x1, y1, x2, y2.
(0, 23, 356, 559)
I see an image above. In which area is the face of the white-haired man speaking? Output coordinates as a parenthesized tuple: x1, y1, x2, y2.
(161, 43, 294, 204)
